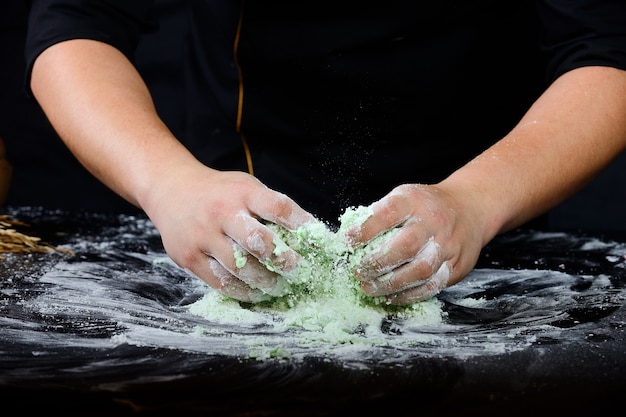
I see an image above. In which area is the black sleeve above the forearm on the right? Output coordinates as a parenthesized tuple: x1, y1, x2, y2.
(537, 0, 626, 81)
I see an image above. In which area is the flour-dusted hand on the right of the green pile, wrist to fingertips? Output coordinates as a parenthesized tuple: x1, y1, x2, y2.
(346, 184, 483, 305)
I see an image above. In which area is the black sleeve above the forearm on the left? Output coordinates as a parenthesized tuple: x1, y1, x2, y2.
(25, 0, 157, 91)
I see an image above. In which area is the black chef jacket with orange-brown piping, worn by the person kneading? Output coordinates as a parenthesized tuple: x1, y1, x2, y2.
(26, 0, 626, 222)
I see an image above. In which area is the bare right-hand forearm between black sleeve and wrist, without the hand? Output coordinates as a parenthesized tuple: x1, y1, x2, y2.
(440, 67, 626, 244)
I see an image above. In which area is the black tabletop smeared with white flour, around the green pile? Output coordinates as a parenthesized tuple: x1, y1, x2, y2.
(0, 207, 626, 416)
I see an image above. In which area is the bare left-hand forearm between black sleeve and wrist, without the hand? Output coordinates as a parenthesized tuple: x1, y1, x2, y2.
(31, 40, 200, 206)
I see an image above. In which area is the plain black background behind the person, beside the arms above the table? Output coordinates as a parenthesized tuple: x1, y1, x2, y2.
(0, 0, 626, 232)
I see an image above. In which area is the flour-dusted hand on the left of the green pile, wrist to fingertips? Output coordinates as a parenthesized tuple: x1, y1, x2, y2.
(144, 165, 316, 302)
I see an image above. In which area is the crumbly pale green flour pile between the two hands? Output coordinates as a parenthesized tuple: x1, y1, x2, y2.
(189, 207, 444, 356)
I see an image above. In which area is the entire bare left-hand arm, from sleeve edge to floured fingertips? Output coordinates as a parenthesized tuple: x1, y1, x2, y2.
(31, 39, 313, 301)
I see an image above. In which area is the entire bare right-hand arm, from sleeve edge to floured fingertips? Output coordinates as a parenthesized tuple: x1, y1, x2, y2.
(350, 66, 626, 304)
